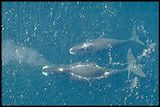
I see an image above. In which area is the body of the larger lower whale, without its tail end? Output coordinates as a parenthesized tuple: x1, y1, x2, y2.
(43, 63, 109, 80)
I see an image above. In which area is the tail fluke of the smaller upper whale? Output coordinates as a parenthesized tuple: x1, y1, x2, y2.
(129, 24, 144, 45)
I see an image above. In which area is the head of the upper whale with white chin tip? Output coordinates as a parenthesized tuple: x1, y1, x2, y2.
(69, 42, 94, 55)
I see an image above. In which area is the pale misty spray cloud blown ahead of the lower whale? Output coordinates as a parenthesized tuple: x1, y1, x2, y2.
(2, 40, 49, 66)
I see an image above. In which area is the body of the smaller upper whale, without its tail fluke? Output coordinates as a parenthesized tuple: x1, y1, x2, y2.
(69, 38, 128, 54)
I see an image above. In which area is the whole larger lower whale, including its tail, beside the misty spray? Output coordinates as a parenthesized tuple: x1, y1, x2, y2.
(42, 48, 146, 80)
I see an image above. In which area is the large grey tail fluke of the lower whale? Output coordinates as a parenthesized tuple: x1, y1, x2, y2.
(127, 48, 146, 77)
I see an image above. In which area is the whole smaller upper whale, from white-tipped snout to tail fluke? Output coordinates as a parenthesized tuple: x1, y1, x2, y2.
(69, 24, 144, 55)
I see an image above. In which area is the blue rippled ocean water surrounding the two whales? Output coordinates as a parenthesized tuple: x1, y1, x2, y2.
(2, 2, 159, 105)
